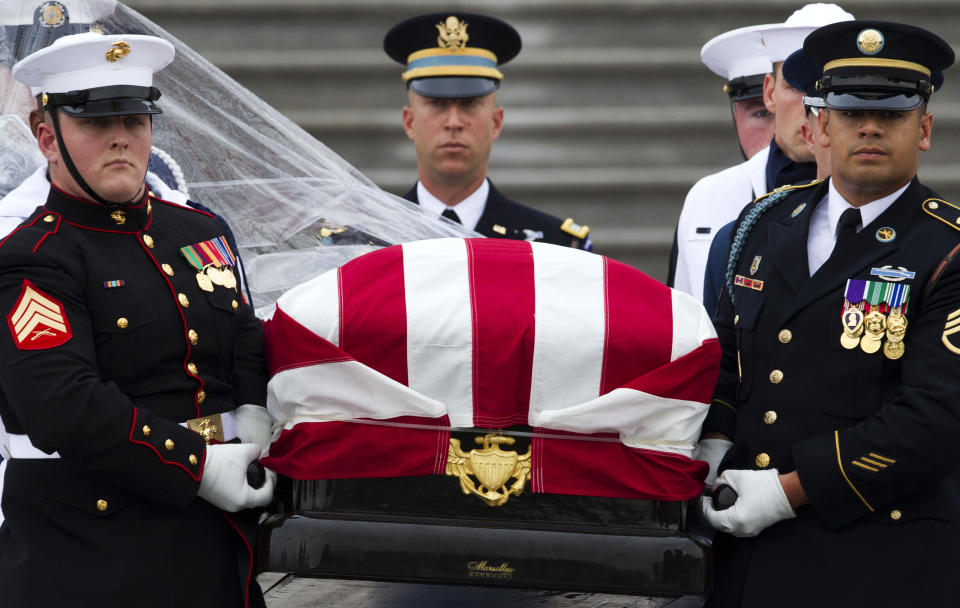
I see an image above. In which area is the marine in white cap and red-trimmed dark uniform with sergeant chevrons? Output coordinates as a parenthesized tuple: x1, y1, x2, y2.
(0, 33, 274, 608)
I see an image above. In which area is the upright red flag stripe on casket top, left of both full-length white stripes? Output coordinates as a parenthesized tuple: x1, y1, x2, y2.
(340, 245, 407, 384)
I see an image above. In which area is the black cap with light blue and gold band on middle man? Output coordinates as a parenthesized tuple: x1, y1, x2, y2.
(383, 12, 521, 98)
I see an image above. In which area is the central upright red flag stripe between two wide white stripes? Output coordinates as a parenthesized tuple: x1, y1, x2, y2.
(467, 239, 535, 427)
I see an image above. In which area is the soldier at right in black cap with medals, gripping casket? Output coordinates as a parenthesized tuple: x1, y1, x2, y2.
(703, 21, 960, 607)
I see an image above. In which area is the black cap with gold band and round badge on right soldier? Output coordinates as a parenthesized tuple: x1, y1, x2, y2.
(803, 20, 954, 111)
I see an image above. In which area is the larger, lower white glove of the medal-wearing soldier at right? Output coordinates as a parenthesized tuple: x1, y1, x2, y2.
(700, 469, 797, 537)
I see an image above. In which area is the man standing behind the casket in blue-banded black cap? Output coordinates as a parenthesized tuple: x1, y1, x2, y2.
(383, 13, 592, 250)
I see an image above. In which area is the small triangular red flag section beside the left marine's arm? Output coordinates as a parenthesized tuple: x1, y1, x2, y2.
(263, 306, 352, 378)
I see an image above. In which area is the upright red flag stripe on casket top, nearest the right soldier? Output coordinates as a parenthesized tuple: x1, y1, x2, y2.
(600, 258, 676, 401)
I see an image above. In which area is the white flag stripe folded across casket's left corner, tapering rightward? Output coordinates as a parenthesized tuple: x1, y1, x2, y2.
(267, 361, 447, 428)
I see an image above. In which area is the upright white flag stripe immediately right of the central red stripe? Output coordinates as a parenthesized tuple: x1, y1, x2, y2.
(529, 243, 606, 421)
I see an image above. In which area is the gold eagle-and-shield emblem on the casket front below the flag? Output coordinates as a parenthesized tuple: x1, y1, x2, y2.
(447, 433, 530, 507)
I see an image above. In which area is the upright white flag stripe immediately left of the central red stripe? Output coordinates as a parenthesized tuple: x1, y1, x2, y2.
(403, 239, 473, 427)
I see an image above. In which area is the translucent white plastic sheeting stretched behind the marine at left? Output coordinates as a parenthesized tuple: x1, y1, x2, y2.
(0, 0, 477, 314)
